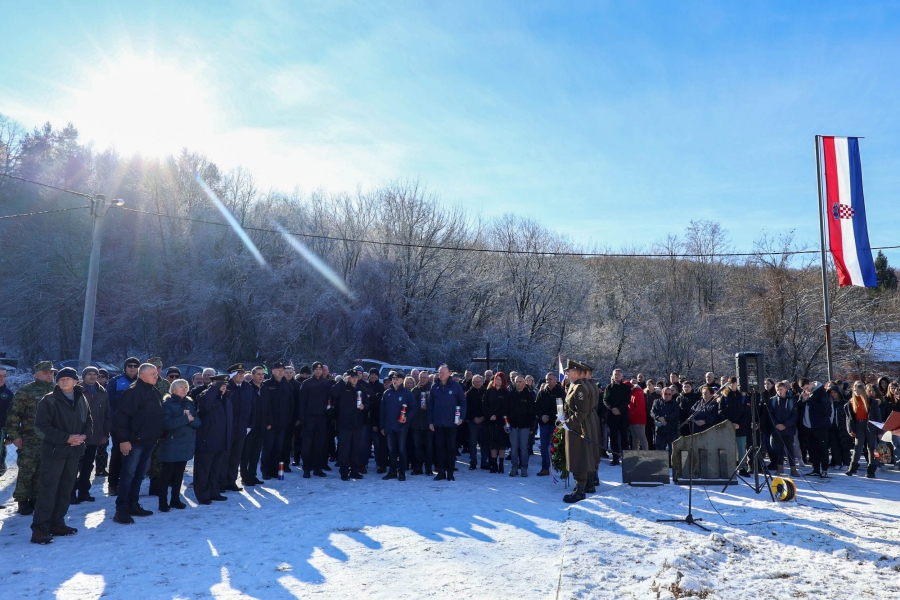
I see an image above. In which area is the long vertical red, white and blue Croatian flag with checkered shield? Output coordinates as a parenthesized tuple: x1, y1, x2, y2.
(822, 136, 878, 287)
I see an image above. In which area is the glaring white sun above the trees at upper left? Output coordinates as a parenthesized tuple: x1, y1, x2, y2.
(66, 54, 216, 156)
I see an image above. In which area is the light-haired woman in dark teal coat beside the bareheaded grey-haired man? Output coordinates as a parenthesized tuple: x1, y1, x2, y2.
(157, 379, 200, 512)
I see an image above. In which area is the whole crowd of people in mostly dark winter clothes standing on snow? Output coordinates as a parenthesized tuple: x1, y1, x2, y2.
(0, 357, 900, 544)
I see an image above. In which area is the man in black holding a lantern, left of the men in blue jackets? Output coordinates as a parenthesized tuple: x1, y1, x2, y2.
(329, 370, 369, 481)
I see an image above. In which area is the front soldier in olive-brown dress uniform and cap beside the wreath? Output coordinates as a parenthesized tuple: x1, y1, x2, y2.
(563, 360, 596, 504)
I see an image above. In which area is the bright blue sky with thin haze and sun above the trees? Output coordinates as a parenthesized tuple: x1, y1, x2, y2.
(0, 0, 900, 266)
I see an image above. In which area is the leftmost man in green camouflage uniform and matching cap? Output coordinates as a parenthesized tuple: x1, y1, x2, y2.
(6, 360, 53, 515)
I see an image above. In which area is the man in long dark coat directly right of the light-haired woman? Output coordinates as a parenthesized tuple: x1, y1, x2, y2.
(194, 375, 234, 504)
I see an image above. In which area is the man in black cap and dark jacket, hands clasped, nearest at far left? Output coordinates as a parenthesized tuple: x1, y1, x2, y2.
(31, 367, 92, 544)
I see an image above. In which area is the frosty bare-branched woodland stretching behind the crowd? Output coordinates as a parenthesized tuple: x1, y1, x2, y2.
(0, 115, 898, 377)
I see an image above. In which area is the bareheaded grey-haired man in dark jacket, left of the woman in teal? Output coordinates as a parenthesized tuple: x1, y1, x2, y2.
(112, 363, 165, 525)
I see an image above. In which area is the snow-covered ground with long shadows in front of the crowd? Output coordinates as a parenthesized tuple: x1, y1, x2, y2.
(0, 451, 900, 600)
